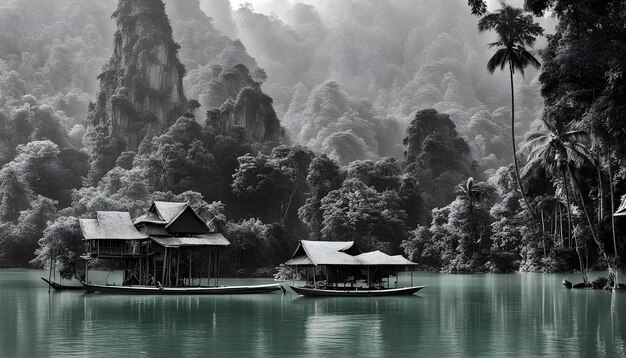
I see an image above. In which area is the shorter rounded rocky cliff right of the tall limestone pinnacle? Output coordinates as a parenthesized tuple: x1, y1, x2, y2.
(207, 65, 283, 142)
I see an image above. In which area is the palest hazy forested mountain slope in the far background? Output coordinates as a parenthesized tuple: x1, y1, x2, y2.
(233, 0, 542, 169)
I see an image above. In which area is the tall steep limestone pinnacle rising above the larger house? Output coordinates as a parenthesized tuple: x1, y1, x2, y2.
(86, 0, 187, 180)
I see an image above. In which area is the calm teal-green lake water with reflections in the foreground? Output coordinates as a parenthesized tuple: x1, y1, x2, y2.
(0, 270, 626, 357)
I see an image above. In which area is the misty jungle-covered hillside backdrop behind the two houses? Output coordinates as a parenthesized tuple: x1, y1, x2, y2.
(0, 0, 626, 276)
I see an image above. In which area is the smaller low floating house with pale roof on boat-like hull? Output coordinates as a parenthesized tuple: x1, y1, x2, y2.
(285, 240, 423, 296)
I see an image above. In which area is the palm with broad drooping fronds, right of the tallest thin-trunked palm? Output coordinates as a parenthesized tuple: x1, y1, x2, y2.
(522, 119, 597, 283)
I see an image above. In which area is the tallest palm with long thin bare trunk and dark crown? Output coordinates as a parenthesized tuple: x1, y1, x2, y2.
(478, 3, 543, 221)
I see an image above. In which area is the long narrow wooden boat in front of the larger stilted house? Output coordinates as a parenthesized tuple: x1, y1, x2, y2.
(82, 282, 281, 295)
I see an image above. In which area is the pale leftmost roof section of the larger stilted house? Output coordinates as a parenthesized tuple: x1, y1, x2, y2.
(78, 211, 148, 240)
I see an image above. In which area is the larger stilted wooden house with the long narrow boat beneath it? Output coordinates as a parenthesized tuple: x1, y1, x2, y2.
(79, 201, 280, 294)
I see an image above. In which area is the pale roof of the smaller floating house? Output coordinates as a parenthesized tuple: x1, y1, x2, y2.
(285, 240, 417, 266)
